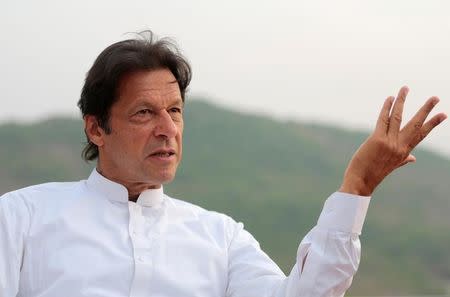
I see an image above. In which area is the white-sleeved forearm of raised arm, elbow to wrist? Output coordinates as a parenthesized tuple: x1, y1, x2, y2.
(279, 193, 369, 297)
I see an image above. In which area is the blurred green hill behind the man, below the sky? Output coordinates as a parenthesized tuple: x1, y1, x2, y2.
(0, 101, 450, 296)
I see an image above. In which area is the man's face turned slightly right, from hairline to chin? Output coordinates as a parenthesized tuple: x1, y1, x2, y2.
(92, 69, 183, 190)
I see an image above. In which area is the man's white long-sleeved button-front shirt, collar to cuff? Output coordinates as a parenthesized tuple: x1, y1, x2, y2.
(0, 170, 370, 297)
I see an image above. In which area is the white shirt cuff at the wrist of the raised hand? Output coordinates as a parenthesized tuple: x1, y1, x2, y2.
(317, 192, 370, 234)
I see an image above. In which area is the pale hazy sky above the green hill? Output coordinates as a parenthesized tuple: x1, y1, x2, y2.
(0, 0, 450, 156)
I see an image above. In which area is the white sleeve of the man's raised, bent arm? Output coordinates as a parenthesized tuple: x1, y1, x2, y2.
(227, 193, 370, 297)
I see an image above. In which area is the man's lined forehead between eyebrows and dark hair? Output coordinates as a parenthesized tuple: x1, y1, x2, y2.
(116, 69, 181, 105)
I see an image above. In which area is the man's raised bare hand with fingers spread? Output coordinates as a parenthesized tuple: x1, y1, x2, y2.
(339, 87, 447, 196)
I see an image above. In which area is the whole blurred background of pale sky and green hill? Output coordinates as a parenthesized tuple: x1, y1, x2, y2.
(0, 0, 450, 296)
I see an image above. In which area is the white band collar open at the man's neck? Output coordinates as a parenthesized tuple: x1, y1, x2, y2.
(87, 168, 164, 207)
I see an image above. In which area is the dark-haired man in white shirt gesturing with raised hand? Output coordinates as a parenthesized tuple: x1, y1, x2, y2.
(0, 33, 446, 297)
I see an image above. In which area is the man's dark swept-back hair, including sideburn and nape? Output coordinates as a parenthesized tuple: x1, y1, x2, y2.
(78, 31, 192, 161)
